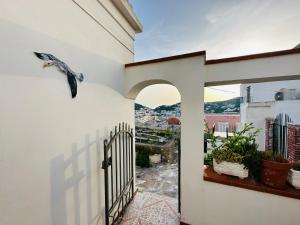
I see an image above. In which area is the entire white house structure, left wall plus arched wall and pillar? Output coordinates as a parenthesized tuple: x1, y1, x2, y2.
(0, 0, 300, 225)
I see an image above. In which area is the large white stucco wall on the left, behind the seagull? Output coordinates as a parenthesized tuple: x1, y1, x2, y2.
(0, 0, 134, 225)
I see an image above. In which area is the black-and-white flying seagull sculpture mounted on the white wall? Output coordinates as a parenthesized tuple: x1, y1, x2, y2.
(34, 52, 84, 98)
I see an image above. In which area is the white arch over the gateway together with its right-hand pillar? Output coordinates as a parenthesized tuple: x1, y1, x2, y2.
(125, 55, 205, 225)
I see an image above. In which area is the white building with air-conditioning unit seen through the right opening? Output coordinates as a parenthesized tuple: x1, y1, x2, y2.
(241, 80, 300, 150)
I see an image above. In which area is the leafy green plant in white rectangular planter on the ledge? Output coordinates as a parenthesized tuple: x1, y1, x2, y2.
(212, 124, 260, 179)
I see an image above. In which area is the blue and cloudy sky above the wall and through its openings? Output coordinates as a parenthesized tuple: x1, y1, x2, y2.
(130, 0, 300, 106)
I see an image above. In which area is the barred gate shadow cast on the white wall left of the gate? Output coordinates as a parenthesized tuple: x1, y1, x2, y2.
(50, 131, 108, 225)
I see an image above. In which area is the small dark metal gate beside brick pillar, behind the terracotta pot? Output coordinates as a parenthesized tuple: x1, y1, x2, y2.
(273, 113, 293, 158)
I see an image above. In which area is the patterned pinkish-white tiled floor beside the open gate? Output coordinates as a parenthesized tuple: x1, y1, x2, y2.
(121, 192, 180, 225)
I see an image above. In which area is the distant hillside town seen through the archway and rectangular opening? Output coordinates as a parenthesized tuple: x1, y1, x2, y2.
(135, 97, 240, 138)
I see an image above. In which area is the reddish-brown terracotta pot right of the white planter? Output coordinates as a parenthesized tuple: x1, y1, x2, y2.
(261, 160, 292, 189)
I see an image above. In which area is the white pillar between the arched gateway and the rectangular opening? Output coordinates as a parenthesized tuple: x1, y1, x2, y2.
(180, 78, 204, 225)
